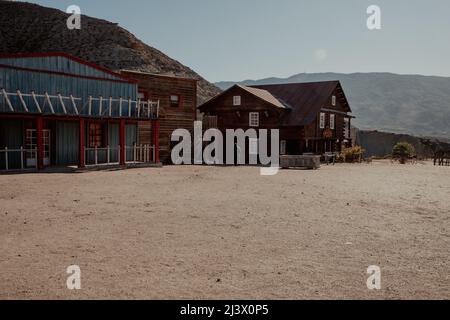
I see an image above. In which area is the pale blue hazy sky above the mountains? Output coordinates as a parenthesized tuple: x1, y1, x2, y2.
(30, 0, 450, 81)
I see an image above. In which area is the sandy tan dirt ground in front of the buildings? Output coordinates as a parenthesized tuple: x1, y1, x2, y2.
(0, 162, 450, 299)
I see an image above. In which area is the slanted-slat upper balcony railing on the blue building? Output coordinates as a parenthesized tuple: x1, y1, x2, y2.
(0, 89, 159, 119)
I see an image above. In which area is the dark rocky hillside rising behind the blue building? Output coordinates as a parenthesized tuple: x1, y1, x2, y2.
(0, 1, 220, 103)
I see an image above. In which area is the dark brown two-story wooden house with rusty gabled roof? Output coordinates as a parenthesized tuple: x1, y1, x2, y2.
(199, 81, 352, 155)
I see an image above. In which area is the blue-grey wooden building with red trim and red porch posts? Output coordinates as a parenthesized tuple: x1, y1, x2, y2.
(0, 53, 159, 170)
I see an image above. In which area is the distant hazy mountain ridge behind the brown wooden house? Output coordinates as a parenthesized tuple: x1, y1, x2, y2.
(216, 73, 450, 138)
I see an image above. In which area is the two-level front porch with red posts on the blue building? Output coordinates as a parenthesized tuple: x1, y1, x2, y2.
(0, 89, 159, 172)
